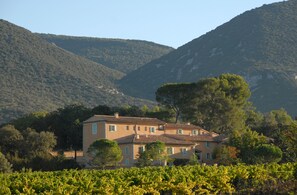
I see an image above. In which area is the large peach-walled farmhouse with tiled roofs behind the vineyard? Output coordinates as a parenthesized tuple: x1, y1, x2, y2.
(83, 113, 220, 167)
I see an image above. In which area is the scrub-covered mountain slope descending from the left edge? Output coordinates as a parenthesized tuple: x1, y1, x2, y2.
(0, 20, 153, 124)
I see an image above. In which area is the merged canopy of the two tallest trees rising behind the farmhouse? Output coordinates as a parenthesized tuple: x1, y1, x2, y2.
(156, 74, 251, 133)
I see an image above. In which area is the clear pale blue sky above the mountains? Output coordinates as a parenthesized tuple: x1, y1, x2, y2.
(0, 0, 280, 48)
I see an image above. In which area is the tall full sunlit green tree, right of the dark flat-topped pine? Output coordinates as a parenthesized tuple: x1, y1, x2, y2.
(183, 74, 251, 133)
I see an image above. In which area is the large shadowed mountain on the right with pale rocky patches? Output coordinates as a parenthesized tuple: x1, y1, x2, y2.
(120, 0, 297, 115)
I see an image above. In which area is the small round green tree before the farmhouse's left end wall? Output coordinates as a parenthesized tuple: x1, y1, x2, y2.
(88, 139, 123, 169)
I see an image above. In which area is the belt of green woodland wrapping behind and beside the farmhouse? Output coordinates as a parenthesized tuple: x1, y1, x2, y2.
(0, 74, 297, 170)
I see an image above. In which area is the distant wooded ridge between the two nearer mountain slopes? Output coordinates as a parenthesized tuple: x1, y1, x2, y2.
(37, 34, 173, 73)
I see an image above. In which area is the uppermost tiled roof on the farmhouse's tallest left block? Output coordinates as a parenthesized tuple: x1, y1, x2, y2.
(84, 115, 165, 125)
